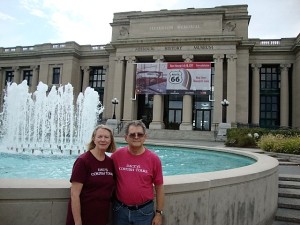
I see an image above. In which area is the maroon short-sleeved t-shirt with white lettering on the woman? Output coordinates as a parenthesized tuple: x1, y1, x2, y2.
(66, 151, 115, 225)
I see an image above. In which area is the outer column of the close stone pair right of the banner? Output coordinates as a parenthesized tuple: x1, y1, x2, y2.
(226, 54, 237, 123)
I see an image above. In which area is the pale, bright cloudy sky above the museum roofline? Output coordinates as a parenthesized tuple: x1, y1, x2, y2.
(0, 0, 300, 47)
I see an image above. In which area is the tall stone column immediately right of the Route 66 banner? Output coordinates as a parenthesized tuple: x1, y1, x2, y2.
(213, 54, 224, 123)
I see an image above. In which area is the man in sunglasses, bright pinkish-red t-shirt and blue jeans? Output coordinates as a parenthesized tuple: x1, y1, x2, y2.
(111, 120, 164, 225)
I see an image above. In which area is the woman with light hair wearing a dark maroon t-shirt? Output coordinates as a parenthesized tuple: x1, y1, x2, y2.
(66, 125, 116, 225)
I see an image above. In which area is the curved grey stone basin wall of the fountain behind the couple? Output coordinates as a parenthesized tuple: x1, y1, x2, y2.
(0, 147, 278, 225)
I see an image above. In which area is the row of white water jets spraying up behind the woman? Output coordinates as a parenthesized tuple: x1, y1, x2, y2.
(0, 80, 104, 154)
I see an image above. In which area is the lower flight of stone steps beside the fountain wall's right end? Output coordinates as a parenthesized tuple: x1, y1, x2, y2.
(272, 174, 300, 225)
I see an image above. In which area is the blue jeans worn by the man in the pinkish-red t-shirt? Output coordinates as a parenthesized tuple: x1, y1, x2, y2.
(113, 201, 154, 225)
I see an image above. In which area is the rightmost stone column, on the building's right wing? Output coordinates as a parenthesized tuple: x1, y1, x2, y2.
(280, 64, 291, 127)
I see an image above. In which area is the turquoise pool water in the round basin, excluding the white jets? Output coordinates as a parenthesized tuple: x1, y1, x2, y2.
(0, 145, 255, 179)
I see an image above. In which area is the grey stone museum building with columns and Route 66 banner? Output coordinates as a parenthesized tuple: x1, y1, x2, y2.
(0, 5, 300, 131)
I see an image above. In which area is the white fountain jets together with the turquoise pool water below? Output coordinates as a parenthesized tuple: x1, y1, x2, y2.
(0, 81, 254, 179)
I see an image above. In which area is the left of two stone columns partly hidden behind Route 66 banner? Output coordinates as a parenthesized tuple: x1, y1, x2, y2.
(149, 55, 165, 130)
